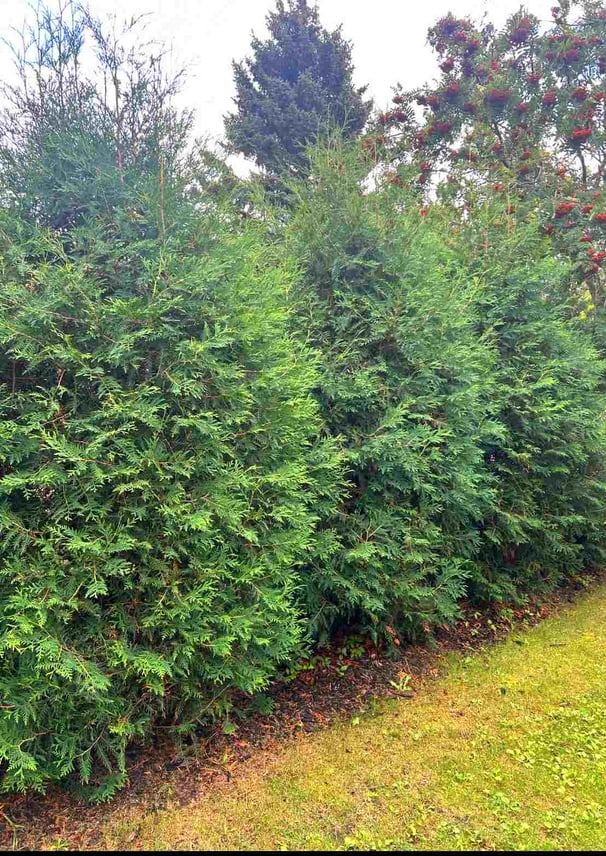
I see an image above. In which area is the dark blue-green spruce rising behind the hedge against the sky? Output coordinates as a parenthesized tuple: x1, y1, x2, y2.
(225, 0, 371, 174)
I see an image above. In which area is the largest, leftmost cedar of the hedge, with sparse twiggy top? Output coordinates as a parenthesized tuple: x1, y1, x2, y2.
(0, 0, 338, 798)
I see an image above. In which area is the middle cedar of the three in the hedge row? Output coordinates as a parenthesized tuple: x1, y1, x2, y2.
(289, 146, 493, 632)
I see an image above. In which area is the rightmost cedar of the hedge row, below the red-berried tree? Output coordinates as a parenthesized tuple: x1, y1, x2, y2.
(443, 204, 606, 598)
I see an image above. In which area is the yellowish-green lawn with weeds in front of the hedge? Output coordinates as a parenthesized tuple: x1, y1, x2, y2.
(104, 589, 606, 850)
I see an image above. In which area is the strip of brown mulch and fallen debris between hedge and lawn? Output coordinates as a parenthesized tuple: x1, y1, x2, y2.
(0, 577, 604, 850)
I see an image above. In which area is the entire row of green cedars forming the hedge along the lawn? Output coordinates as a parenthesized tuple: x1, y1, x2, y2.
(0, 3, 606, 798)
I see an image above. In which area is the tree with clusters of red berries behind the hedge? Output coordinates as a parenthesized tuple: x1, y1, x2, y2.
(376, 0, 606, 326)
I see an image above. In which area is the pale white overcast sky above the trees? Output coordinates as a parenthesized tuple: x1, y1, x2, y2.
(0, 0, 553, 171)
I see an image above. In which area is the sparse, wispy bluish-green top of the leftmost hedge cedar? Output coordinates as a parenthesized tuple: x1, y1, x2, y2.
(0, 2, 191, 237)
